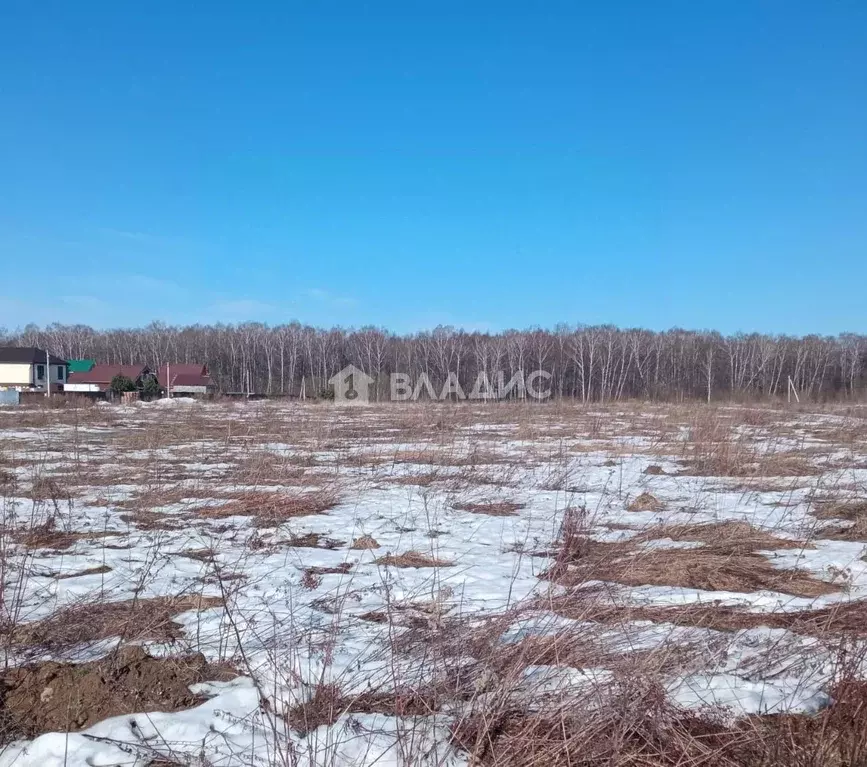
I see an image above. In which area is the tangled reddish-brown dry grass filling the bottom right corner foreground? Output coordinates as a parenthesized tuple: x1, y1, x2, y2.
(454, 679, 867, 767)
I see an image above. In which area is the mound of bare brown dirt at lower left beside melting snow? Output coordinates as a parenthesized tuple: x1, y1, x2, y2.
(0, 646, 237, 742)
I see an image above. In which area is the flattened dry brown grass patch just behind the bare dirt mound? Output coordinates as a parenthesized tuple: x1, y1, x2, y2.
(11, 595, 223, 651)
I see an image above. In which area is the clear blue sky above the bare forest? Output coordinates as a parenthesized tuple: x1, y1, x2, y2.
(0, 0, 867, 333)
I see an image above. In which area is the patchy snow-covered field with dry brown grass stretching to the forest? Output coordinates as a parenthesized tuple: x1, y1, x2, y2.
(0, 400, 867, 767)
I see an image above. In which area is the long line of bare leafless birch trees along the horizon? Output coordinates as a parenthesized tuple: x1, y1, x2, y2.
(0, 323, 867, 402)
